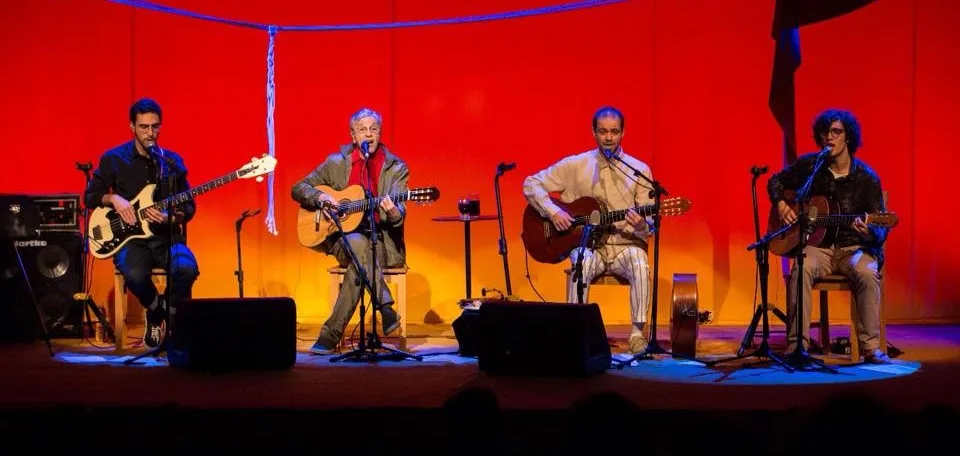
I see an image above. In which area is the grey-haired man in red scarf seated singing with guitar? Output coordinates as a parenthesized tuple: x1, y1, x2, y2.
(292, 108, 410, 354)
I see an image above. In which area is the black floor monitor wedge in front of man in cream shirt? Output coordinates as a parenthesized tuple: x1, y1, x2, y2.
(477, 301, 611, 377)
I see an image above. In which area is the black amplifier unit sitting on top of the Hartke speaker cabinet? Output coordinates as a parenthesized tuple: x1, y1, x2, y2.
(0, 194, 80, 238)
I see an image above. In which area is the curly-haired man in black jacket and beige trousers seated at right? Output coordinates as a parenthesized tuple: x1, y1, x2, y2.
(767, 109, 890, 364)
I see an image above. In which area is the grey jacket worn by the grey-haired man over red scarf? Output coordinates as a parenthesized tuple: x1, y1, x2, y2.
(292, 144, 410, 266)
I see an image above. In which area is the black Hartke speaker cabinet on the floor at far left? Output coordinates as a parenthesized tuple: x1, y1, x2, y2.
(0, 232, 83, 342)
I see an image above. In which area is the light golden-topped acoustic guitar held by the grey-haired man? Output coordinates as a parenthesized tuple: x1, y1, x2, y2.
(297, 185, 440, 247)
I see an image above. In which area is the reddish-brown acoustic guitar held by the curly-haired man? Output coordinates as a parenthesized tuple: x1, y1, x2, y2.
(767, 191, 900, 256)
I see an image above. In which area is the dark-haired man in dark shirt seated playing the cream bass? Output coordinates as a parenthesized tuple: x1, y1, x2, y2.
(84, 98, 199, 347)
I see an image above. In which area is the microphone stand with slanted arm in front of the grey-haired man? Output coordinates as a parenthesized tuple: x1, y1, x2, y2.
(327, 153, 423, 363)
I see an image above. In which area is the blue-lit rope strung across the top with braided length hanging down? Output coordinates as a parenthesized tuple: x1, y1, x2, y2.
(107, 0, 627, 236)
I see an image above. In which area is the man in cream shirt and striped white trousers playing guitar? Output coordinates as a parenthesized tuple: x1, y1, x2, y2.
(523, 107, 654, 353)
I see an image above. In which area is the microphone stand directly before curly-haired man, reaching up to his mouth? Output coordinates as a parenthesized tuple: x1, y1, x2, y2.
(785, 153, 838, 374)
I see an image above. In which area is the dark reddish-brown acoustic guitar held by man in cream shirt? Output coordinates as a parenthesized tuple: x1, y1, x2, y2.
(520, 196, 691, 264)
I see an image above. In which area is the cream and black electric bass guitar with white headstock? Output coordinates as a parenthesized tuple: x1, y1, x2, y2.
(87, 155, 277, 259)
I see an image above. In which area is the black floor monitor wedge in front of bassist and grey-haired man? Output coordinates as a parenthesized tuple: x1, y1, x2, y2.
(167, 297, 297, 372)
